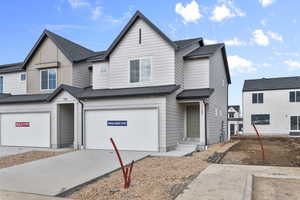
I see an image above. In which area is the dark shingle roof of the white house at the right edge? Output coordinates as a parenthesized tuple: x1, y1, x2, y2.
(243, 76, 300, 91)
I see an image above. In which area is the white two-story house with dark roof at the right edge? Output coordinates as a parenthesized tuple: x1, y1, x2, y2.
(243, 77, 300, 136)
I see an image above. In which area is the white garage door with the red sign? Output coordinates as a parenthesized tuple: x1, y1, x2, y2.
(1, 113, 50, 147)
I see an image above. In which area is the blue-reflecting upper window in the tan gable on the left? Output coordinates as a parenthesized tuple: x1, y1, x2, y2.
(41, 69, 57, 90)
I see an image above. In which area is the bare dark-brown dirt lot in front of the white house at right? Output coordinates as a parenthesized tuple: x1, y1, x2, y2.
(220, 137, 300, 167)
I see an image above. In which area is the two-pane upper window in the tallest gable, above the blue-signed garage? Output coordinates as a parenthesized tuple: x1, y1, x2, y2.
(129, 58, 151, 83)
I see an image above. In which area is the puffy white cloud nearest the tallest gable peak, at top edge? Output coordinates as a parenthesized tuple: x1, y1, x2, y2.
(175, 0, 202, 24)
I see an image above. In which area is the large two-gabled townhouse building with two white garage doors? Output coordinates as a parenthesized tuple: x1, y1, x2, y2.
(0, 11, 231, 151)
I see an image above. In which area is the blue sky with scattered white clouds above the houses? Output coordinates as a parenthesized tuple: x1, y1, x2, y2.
(0, 0, 300, 104)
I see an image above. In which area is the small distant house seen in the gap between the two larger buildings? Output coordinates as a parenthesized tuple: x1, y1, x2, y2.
(228, 105, 243, 135)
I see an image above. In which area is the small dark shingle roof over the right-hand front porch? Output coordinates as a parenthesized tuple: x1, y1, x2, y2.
(176, 88, 214, 100)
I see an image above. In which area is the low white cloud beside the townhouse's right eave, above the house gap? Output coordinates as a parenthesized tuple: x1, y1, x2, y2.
(228, 55, 256, 73)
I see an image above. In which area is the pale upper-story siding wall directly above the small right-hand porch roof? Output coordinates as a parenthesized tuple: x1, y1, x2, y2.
(184, 58, 210, 89)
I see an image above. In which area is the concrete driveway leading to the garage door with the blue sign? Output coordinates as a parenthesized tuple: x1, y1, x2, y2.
(0, 150, 149, 196)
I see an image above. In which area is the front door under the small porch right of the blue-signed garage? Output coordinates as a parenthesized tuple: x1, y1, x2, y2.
(186, 104, 200, 138)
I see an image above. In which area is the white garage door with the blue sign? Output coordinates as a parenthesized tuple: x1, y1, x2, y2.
(85, 109, 158, 151)
